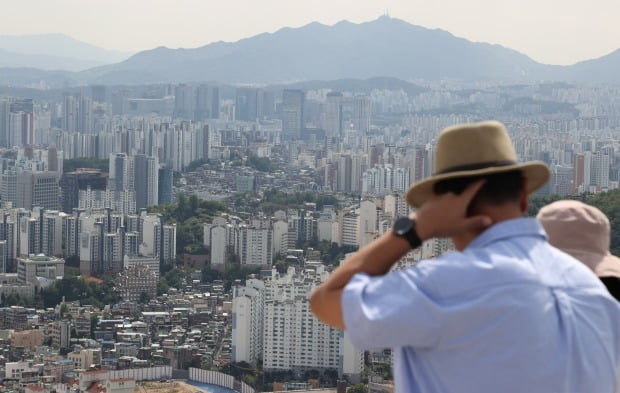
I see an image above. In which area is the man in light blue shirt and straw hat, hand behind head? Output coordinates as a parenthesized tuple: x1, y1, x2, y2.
(310, 122, 620, 393)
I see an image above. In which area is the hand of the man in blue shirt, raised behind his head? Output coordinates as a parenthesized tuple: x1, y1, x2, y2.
(413, 180, 492, 240)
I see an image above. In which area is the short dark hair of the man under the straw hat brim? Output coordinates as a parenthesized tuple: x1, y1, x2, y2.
(433, 170, 523, 205)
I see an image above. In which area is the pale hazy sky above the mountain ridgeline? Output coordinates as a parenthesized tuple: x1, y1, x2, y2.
(0, 0, 620, 64)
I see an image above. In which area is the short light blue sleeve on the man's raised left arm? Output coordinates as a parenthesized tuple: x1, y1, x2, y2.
(342, 270, 445, 349)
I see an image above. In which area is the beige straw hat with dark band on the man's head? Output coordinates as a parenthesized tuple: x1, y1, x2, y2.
(407, 121, 551, 207)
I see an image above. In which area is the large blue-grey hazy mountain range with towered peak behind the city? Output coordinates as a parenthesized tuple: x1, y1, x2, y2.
(0, 17, 620, 85)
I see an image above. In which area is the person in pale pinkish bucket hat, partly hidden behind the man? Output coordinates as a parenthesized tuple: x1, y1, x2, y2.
(536, 200, 620, 300)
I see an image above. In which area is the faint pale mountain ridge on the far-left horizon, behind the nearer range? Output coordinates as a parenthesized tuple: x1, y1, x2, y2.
(0, 34, 132, 71)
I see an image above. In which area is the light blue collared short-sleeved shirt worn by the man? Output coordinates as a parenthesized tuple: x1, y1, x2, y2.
(342, 218, 620, 393)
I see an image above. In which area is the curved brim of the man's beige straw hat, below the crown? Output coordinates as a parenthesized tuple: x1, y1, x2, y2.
(407, 161, 551, 208)
